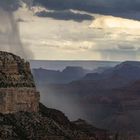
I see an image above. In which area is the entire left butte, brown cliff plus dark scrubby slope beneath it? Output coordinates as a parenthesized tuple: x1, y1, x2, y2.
(0, 51, 109, 140)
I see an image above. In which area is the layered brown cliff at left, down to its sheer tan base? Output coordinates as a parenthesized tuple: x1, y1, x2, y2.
(0, 52, 39, 113)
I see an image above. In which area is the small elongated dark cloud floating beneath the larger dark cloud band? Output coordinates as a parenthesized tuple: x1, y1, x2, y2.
(36, 10, 93, 22)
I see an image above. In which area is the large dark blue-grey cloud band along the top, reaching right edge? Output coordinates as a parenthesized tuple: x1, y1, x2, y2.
(34, 0, 140, 19)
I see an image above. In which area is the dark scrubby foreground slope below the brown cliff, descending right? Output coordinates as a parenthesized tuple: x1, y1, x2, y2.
(0, 104, 108, 140)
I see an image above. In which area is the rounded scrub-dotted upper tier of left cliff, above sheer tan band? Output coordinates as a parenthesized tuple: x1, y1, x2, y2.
(0, 52, 35, 88)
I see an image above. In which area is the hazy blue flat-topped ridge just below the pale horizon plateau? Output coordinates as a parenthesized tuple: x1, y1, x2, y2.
(32, 66, 92, 84)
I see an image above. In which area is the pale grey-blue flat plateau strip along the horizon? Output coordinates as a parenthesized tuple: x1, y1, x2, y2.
(30, 60, 120, 70)
